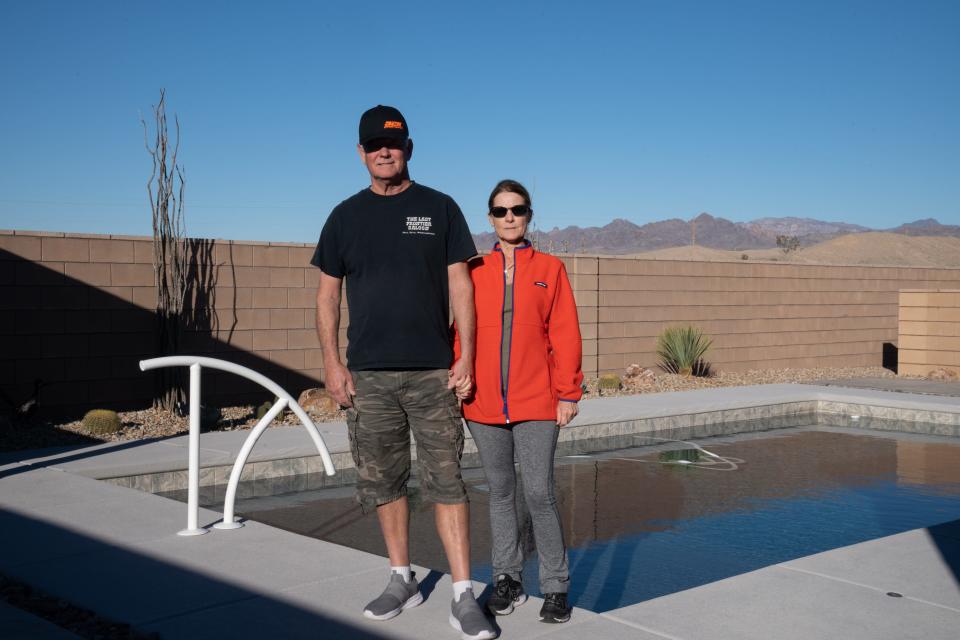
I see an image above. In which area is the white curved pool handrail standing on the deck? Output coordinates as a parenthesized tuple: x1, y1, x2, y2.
(140, 356, 335, 536)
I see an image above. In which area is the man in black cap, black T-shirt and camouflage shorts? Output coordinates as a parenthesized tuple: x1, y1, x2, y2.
(311, 106, 496, 639)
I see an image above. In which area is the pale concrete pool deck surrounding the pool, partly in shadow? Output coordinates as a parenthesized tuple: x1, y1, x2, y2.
(0, 384, 960, 640)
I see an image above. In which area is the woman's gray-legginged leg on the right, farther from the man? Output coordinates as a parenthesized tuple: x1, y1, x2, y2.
(513, 420, 570, 593)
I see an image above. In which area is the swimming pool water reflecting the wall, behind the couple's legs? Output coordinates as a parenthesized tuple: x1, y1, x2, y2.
(163, 426, 960, 612)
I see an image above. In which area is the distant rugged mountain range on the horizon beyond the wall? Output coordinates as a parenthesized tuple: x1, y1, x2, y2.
(473, 213, 960, 255)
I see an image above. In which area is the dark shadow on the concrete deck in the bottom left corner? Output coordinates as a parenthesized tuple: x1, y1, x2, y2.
(0, 509, 386, 640)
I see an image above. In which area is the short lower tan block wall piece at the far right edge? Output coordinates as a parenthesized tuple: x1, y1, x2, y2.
(899, 289, 960, 375)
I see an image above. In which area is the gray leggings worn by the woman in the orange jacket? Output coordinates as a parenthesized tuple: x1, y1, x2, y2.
(467, 420, 570, 593)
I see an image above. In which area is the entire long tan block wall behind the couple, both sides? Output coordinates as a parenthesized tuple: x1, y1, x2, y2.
(0, 231, 960, 411)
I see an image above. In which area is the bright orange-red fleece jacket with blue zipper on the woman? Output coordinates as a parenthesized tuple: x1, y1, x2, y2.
(454, 242, 583, 424)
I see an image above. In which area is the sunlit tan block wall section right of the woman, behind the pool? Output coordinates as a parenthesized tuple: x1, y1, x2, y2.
(566, 256, 960, 374)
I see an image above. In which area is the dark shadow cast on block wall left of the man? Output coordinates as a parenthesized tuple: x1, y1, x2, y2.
(0, 248, 320, 428)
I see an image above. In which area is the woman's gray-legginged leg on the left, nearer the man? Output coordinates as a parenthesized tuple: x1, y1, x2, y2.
(467, 420, 523, 580)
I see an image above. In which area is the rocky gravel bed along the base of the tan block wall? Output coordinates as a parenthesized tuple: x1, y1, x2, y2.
(0, 367, 896, 451)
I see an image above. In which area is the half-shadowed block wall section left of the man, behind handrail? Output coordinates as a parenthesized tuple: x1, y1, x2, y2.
(0, 231, 338, 414)
